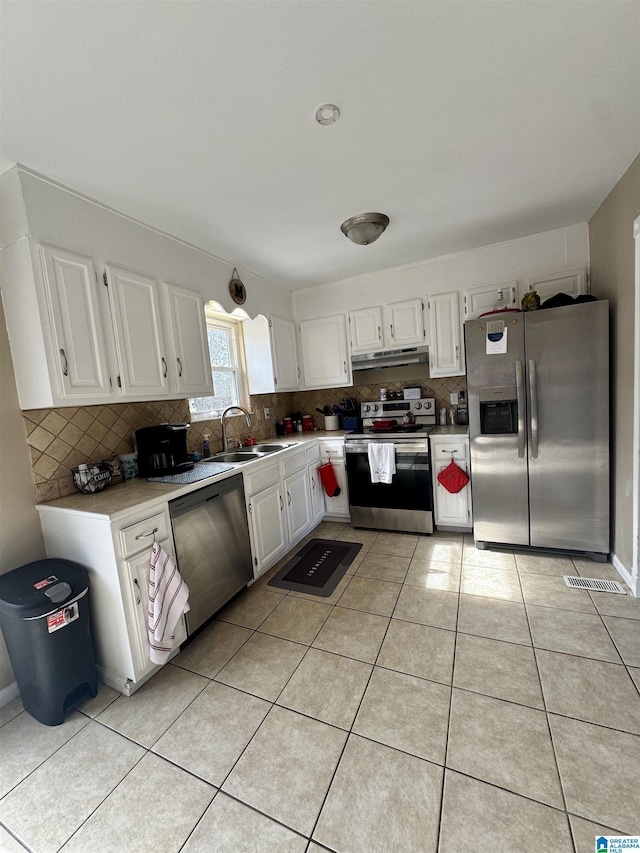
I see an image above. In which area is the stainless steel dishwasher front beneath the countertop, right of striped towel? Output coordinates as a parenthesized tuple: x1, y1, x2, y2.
(169, 474, 253, 634)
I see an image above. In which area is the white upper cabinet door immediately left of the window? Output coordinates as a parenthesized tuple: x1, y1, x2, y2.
(167, 284, 213, 397)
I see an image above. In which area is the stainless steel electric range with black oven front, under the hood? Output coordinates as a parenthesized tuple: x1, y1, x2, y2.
(345, 397, 436, 533)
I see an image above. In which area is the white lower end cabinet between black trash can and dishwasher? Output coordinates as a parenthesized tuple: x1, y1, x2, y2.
(38, 504, 187, 695)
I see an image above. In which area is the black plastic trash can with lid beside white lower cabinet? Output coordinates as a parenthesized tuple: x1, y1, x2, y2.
(0, 560, 98, 726)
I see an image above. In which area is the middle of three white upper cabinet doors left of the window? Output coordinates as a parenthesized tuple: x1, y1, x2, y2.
(106, 266, 169, 399)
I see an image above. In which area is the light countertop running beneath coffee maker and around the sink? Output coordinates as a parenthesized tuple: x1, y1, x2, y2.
(36, 430, 347, 519)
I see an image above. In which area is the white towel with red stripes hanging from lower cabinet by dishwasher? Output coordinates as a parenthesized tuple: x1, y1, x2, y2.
(149, 542, 189, 663)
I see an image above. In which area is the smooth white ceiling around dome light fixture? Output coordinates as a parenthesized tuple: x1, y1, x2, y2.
(0, 0, 640, 289)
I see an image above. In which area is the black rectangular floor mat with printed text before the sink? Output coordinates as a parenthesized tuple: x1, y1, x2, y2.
(267, 539, 362, 598)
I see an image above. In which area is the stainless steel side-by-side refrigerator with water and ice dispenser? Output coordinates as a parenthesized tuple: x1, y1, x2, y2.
(465, 301, 609, 559)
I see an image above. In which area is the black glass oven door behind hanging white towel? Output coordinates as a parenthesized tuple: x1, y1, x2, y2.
(345, 441, 433, 520)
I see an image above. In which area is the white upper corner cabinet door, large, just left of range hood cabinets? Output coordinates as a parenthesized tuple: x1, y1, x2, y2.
(300, 314, 351, 388)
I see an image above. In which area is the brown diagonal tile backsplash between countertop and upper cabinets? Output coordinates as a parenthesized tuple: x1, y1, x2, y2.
(22, 376, 466, 503)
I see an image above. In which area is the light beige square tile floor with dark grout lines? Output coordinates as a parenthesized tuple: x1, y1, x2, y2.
(0, 523, 640, 853)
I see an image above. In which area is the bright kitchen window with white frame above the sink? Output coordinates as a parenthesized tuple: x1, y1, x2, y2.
(189, 307, 249, 421)
